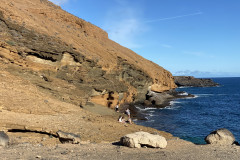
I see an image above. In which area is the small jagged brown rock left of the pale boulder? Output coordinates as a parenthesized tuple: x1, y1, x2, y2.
(57, 130, 81, 144)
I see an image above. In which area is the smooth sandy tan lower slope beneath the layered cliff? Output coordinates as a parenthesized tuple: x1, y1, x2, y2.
(0, 63, 171, 145)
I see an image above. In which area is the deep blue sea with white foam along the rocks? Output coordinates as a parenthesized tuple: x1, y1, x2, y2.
(135, 78, 240, 144)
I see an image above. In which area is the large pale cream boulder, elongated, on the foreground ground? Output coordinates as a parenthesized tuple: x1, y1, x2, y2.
(120, 132, 167, 148)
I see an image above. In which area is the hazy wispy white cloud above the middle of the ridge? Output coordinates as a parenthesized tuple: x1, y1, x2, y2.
(102, 0, 146, 49)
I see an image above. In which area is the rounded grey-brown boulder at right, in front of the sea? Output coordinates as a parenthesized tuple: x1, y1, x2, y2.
(205, 128, 235, 145)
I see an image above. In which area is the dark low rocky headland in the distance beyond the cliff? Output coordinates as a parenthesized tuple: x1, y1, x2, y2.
(174, 76, 219, 87)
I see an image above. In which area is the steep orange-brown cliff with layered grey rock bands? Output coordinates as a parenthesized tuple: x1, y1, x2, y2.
(0, 0, 176, 108)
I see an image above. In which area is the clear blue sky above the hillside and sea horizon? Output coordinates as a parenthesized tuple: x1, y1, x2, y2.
(51, 0, 240, 77)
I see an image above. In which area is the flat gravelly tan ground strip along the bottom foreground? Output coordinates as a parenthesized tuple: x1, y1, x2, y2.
(0, 139, 240, 160)
